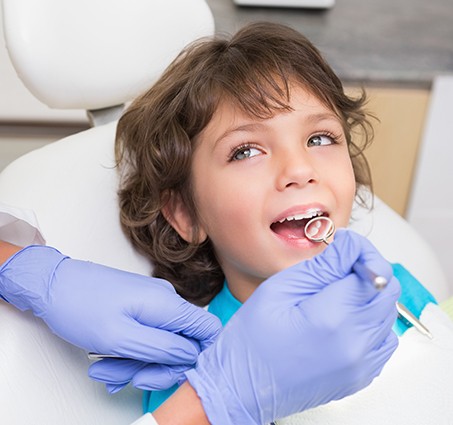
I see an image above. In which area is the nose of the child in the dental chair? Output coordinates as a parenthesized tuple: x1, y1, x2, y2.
(276, 150, 319, 191)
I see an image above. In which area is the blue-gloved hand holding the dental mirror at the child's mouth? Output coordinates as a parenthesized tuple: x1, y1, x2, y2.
(185, 230, 400, 425)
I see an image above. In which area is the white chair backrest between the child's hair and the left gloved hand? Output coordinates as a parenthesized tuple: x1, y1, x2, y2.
(0, 122, 151, 274)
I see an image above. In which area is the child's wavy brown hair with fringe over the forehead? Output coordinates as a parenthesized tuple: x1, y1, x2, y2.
(116, 23, 372, 305)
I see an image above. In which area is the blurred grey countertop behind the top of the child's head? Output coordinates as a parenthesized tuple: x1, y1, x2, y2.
(207, 0, 453, 87)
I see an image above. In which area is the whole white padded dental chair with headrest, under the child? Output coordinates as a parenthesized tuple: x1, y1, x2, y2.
(0, 0, 449, 425)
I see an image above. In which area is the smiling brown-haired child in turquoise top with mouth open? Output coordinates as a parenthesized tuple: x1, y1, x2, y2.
(117, 23, 451, 423)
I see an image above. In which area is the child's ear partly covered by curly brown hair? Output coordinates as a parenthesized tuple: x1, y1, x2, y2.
(162, 192, 208, 244)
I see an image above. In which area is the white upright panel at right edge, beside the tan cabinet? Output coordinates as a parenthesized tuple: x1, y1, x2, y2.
(402, 75, 453, 294)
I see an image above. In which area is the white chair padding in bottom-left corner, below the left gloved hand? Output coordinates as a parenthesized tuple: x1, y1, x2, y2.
(0, 301, 142, 425)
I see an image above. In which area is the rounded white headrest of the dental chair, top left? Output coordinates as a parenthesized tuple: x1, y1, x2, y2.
(3, 0, 214, 109)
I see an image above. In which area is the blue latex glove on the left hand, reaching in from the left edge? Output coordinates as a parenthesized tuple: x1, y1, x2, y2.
(0, 246, 221, 386)
